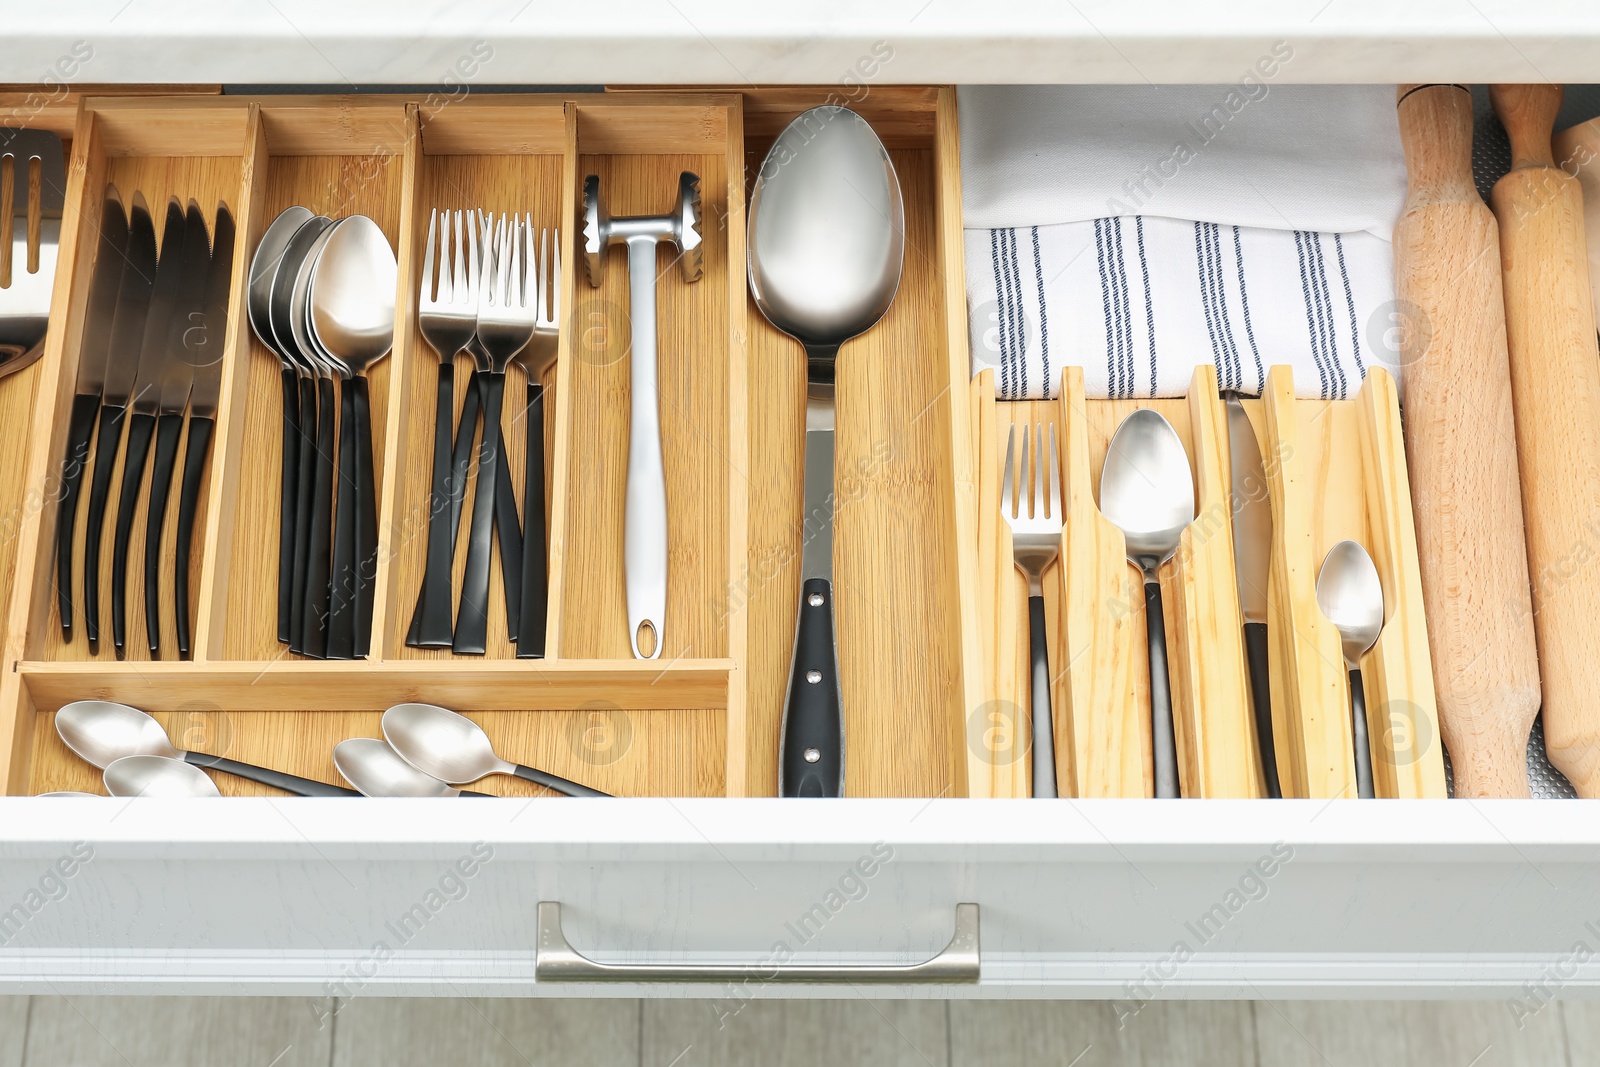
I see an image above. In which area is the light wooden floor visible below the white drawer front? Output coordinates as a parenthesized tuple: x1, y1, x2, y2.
(0, 997, 1600, 1067)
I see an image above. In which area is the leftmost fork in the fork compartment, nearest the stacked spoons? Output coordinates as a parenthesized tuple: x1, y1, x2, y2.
(405, 210, 476, 648)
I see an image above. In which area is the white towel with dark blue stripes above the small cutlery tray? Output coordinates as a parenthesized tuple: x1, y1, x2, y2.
(966, 216, 1400, 400)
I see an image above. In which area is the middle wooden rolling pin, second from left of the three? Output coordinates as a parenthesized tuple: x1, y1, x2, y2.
(1490, 85, 1600, 798)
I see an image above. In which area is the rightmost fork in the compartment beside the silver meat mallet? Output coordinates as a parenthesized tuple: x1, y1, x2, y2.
(517, 229, 562, 659)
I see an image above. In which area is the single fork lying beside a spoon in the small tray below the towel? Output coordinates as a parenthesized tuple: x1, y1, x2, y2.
(1000, 422, 1061, 797)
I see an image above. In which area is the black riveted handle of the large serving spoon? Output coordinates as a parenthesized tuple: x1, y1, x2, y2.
(778, 577, 845, 797)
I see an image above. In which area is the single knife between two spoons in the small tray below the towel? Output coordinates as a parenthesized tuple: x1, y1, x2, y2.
(1227, 397, 1283, 798)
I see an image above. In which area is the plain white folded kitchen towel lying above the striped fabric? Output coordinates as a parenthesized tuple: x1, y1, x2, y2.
(958, 82, 1405, 240)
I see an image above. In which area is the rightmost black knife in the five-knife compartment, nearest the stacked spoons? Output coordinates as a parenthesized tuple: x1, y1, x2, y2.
(173, 203, 234, 659)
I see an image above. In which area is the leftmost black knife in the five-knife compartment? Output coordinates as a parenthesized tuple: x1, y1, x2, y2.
(56, 184, 128, 641)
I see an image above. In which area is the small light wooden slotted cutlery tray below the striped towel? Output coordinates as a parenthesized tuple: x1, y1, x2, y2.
(970, 366, 1445, 797)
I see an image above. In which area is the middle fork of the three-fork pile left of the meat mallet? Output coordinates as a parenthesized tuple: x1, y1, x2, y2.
(451, 214, 538, 656)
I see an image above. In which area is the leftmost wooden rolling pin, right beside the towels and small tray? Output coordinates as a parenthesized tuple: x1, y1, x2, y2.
(1394, 85, 1539, 797)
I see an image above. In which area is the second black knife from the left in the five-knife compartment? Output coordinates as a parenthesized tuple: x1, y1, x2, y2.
(83, 190, 157, 653)
